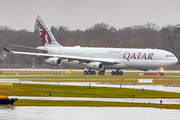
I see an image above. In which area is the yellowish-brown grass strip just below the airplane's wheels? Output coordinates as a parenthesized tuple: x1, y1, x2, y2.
(0, 71, 180, 87)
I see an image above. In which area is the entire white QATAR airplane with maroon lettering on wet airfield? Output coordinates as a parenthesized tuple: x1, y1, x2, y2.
(3, 18, 178, 75)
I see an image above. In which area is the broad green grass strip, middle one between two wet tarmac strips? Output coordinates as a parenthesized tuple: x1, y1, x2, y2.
(0, 84, 180, 98)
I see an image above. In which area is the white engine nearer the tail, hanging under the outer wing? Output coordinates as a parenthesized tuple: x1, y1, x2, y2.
(45, 58, 62, 66)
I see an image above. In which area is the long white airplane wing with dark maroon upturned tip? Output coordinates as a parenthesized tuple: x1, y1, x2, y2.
(3, 47, 115, 63)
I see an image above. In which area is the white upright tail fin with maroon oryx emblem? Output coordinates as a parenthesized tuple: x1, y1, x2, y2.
(36, 18, 62, 47)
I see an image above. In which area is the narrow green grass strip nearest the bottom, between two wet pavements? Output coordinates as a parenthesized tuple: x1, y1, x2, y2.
(3, 100, 180, 109)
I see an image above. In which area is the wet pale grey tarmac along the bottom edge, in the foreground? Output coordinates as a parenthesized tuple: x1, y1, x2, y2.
(0, 107, 180, 120)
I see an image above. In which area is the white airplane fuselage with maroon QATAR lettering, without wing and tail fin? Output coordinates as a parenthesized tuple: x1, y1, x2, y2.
(47, 46, 178, 69)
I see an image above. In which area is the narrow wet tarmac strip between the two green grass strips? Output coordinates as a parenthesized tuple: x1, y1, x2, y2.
(9, 96, 180, 104)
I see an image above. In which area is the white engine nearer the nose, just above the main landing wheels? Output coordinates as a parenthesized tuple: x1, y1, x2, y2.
(86, 62, 104, 70)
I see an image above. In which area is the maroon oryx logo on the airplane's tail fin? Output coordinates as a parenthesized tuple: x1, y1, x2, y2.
(36, 20, 52, 46)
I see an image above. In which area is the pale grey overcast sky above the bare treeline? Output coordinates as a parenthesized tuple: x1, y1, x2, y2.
(0, 0, 180, 31)
